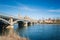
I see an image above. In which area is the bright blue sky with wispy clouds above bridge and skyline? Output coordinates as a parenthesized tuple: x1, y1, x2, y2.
(0, 0, 60, 19)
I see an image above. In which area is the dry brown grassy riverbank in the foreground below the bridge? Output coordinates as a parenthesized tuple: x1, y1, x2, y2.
(0, 30, 28, 40)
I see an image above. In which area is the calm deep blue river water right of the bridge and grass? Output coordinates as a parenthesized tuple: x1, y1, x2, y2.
(14, 24, 60, 40)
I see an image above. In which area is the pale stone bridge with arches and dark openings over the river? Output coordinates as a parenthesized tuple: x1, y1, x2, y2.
(0, 16, 34, 28)
